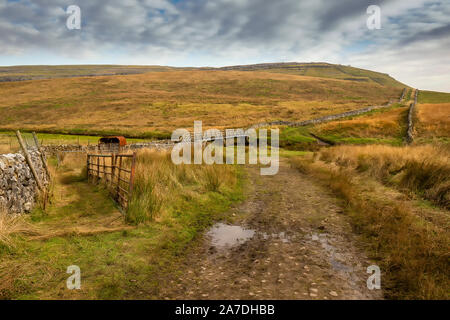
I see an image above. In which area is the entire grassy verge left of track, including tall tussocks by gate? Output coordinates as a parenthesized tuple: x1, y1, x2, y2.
(0, 152, 242, 299)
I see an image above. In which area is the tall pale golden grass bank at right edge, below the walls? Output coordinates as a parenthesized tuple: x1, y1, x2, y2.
(319, 145, 450, 209)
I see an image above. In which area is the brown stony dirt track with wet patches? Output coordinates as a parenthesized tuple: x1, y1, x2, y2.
(160, 161, 382, 299)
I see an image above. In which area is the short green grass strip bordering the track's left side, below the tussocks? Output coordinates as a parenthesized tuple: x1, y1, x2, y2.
(6, 191, 240, 299)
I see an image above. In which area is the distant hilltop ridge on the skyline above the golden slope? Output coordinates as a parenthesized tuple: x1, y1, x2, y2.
(0, 62, 406, 87)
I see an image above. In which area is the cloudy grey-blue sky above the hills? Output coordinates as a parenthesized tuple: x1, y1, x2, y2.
(0, 0, 450, 92)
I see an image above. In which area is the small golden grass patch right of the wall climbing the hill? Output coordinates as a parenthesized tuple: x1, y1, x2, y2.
(416, 103, 450, 138)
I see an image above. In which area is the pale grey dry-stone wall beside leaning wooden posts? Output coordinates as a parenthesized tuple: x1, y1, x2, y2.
(0, 150, 49, 213)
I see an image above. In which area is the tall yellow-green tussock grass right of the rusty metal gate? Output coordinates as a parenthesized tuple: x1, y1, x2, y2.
(126, 149, 237, 224)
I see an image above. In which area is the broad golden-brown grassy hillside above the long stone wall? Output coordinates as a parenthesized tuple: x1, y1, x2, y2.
(0, 71, 401, 136)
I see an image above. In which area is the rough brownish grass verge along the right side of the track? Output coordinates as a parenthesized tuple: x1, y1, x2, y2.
(291, 151, 450, 299)
